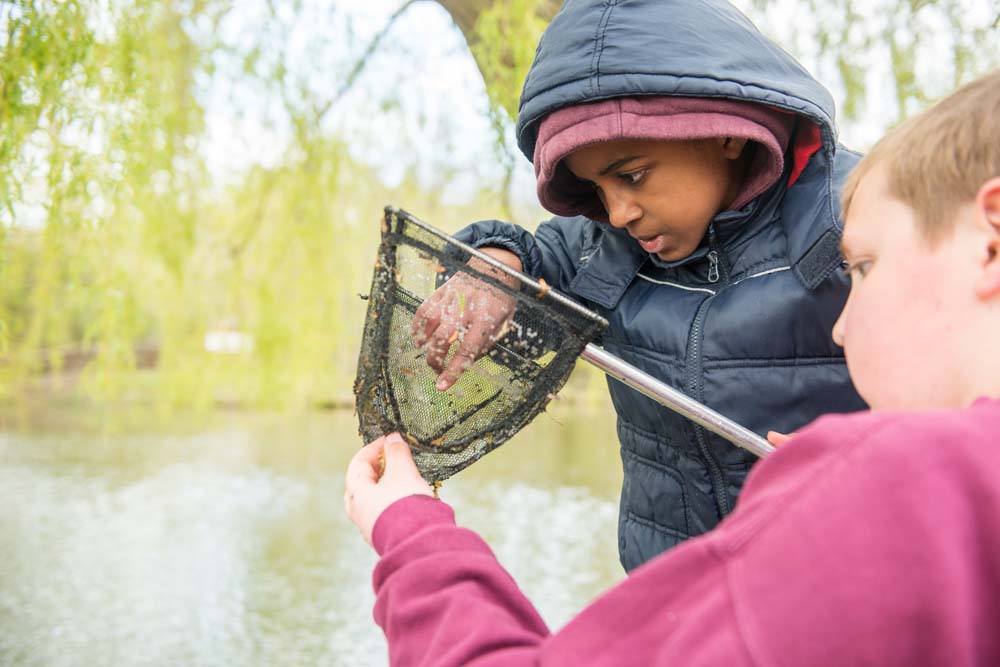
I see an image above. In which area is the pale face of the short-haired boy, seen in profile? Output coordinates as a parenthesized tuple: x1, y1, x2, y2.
(833, 167, 985, 409)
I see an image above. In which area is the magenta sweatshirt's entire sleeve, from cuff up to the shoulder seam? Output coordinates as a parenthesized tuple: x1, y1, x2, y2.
(372, 496, 746, 667)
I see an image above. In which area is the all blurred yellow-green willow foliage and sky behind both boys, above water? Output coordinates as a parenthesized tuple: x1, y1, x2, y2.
(0, 0, 1000, 409)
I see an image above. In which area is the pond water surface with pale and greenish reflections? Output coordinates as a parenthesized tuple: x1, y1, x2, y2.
(0, 404, 623, 666)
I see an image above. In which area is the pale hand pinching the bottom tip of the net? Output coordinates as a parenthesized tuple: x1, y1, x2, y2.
(344, 433, 434, 544)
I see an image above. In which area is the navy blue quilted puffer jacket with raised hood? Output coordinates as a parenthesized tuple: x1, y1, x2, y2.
(459, 0, 864, 569)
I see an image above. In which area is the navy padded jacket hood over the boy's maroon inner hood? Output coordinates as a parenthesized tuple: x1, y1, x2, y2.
(516, 0, 836, 160)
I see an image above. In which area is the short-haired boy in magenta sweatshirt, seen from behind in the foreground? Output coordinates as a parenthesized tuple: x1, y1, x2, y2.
(345, 71, 1000, 666)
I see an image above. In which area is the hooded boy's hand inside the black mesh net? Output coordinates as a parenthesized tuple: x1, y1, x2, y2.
(410, 248, 521, 391)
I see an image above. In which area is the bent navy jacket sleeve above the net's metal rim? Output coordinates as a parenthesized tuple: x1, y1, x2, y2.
(455, 217, 600, 292)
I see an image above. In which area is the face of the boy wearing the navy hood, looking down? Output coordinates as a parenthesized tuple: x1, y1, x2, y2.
(566, 139, 745, 262)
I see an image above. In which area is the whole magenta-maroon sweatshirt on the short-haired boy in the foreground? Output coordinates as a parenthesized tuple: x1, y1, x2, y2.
(373, 399, 1000, 667)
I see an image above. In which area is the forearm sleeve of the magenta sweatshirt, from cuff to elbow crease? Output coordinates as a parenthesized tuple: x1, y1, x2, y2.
(372, 496, 549, 667)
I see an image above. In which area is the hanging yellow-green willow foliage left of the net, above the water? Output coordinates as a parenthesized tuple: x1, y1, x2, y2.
(0, 0, 516, 406)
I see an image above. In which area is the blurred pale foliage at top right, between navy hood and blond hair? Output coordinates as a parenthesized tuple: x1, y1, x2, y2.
(740, 0, 1000, 127)
